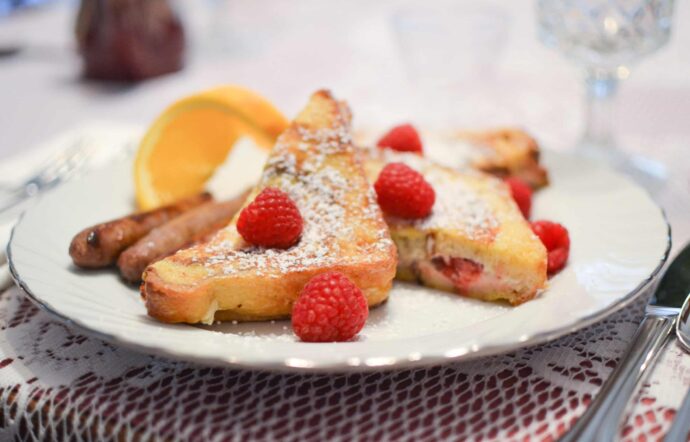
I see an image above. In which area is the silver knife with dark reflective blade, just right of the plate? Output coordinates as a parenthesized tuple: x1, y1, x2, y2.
(561, 244, 690, 442)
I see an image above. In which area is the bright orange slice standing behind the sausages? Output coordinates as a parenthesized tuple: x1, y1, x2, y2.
(134, 86, 288, 210)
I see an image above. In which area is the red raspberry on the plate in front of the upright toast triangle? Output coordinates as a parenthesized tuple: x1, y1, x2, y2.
(292, 272, 369, 342)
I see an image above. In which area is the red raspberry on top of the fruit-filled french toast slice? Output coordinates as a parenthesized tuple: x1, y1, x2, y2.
(374, 163, 436, 218)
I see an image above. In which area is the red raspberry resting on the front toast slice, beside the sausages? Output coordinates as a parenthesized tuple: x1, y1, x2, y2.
(237, 187, 304, 249)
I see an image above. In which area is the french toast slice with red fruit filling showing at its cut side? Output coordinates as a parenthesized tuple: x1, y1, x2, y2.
(365, 148, 547, 305)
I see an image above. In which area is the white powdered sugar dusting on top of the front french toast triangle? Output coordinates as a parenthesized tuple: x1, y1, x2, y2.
(192, 122, 395, 278)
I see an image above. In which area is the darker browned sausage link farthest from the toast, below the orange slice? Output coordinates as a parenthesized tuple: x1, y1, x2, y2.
(69, 193, 213, 268)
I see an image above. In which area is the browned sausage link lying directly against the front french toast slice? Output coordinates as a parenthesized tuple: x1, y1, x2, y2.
(117, 192, 248, 282)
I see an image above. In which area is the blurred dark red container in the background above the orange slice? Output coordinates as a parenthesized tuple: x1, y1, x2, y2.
(76, 0, 185, 81)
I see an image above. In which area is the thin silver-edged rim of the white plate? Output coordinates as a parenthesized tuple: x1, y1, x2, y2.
(6, 157, 672, 373)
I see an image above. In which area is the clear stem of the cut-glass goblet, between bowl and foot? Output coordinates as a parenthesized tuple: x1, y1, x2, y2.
(583, 68, 619, 149)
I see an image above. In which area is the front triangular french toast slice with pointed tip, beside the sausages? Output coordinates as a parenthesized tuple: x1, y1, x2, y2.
(141, 91, 397, 323)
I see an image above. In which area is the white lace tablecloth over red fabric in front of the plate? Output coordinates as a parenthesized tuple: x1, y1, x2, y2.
(0, 288, 690, 441)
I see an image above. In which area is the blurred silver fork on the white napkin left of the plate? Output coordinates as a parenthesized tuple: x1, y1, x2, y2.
(0, 139, 95, 213)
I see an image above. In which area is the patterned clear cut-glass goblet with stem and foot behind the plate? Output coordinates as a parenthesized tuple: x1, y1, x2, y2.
(537, 0, 673, 179)
